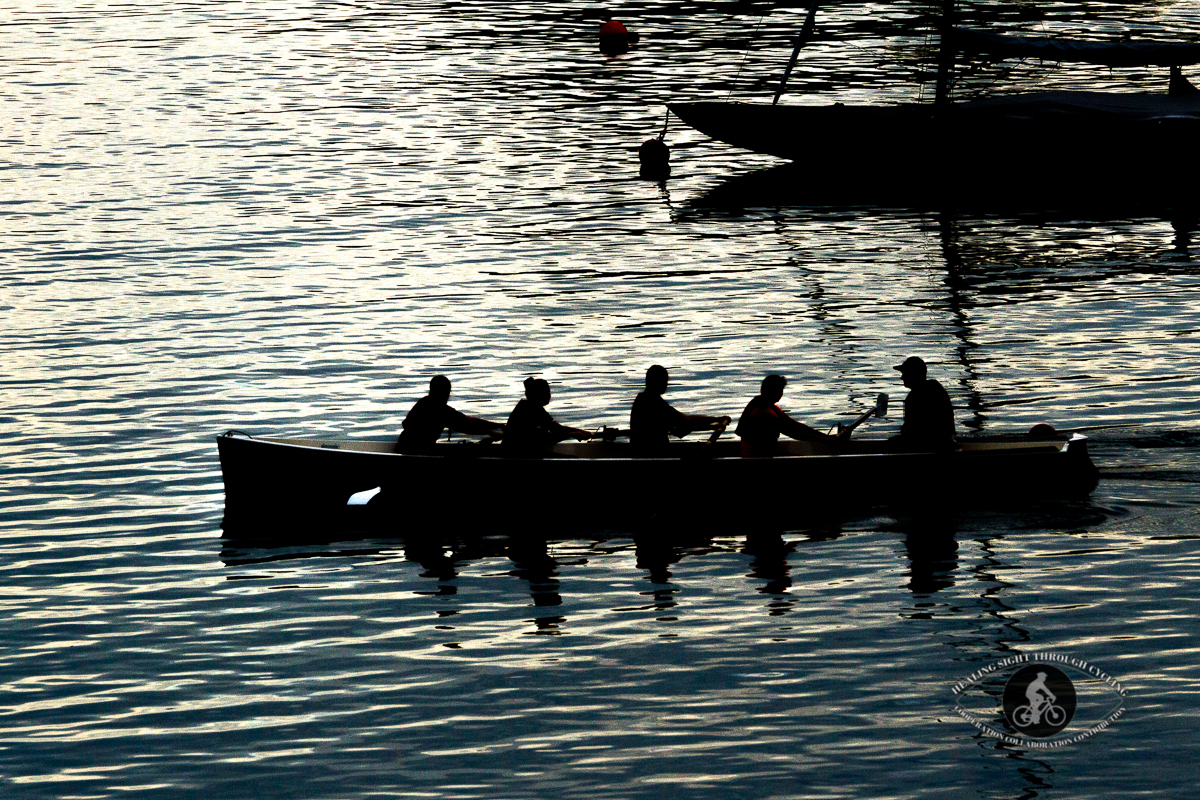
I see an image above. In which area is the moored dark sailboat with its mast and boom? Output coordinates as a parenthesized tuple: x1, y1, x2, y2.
(668, 1, 1200, 185)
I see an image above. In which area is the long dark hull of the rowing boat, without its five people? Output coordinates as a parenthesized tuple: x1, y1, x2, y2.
(217, 433, 1097, 525)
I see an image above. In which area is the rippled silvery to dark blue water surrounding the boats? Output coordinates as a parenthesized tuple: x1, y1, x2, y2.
(0, 2, 1200, 798)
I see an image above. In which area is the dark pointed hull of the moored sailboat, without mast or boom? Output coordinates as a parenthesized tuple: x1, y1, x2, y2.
(668, 92, 1200, 185)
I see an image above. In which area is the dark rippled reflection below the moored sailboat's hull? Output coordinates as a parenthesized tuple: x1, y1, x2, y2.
(674, 163, 1200, 284)
